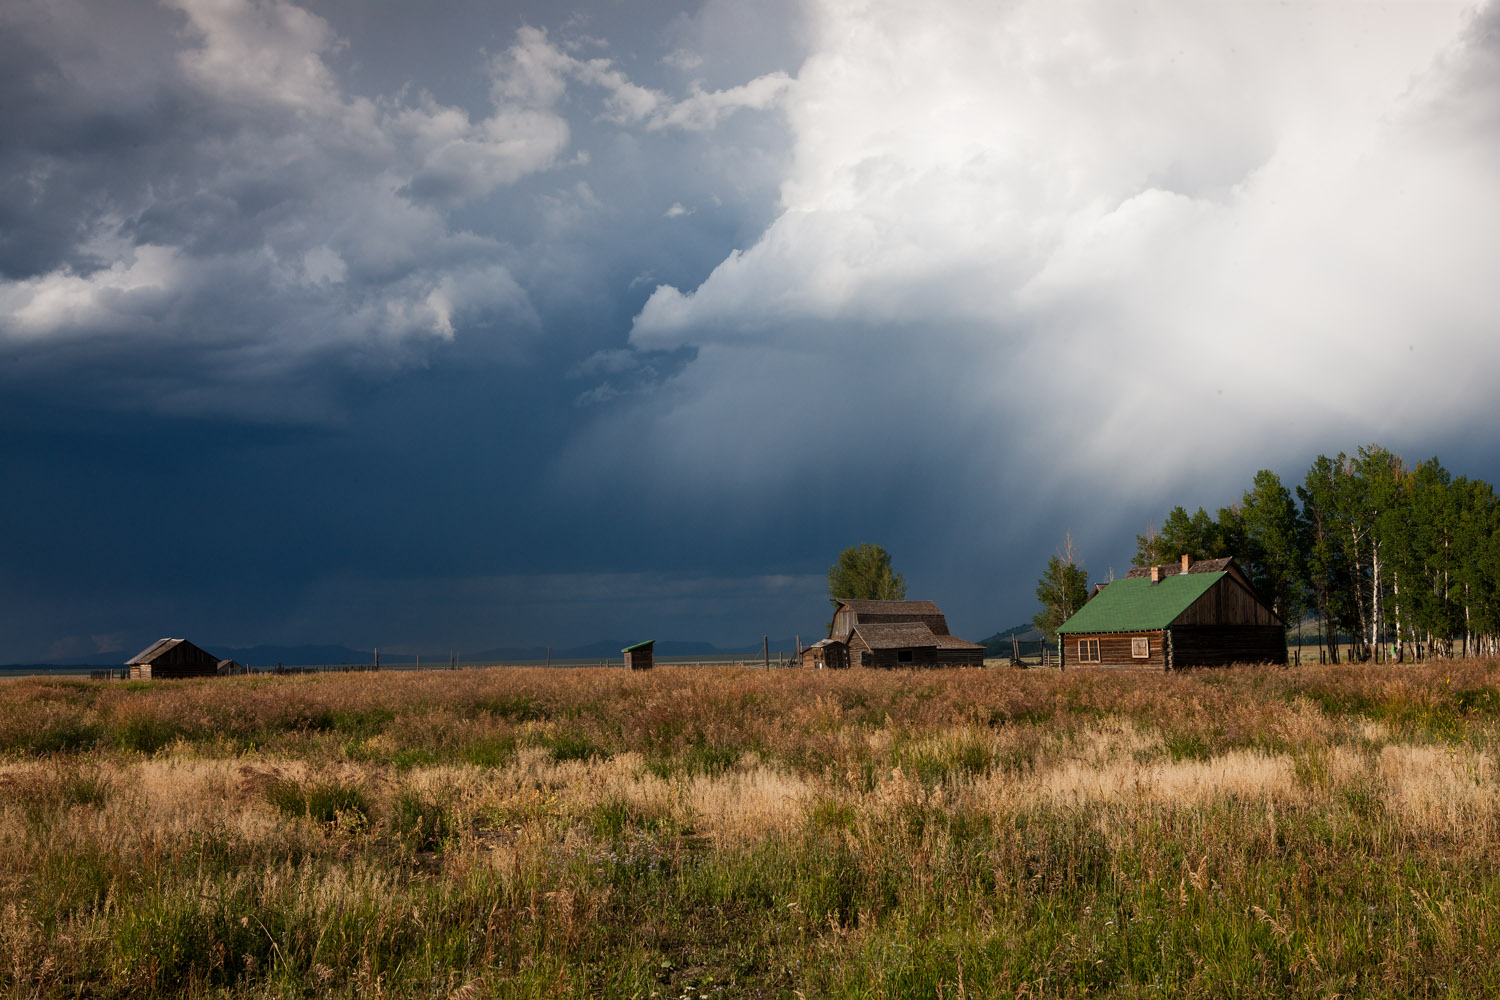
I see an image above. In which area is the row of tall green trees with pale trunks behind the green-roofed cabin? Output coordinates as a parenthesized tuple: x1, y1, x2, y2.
(1133, 445, 1500, 663)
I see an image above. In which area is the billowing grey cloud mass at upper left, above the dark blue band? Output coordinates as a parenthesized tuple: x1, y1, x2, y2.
(0, 0, 786, 418)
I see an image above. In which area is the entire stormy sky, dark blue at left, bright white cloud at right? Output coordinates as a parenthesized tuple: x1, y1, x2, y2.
(0, 0, 1500, 661)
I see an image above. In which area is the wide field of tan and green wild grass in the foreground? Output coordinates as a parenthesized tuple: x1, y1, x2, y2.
(0, 661, 1500, 1000)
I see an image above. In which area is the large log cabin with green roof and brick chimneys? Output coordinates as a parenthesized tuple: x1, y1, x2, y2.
(1058, 556, 1287, 670)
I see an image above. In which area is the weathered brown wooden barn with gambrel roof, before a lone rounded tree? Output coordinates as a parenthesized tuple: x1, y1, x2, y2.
(830, 600, 984, 667)
